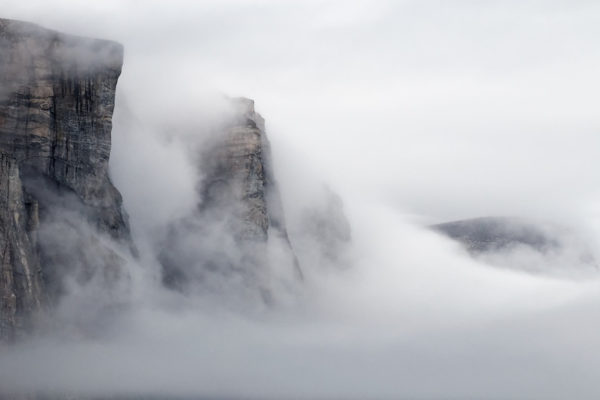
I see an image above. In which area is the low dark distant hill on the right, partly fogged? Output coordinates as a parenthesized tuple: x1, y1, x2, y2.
(432, 217, 599, 278)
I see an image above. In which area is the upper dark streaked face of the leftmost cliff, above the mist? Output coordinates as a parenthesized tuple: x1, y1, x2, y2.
(0, 20, 129, 238)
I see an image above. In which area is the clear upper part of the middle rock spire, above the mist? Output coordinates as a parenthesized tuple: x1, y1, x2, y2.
(200, 98, 287, 244)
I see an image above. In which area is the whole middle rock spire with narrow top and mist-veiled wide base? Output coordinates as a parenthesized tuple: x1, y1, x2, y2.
(161, 98, 302, 302)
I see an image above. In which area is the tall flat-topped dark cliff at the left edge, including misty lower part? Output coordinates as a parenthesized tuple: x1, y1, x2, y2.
(0, 19, 130, 336)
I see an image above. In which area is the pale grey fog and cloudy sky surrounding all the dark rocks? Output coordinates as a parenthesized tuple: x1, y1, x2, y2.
(0, 0, 600, 399)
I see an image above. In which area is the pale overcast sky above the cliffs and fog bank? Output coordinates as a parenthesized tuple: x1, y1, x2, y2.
(2, 0, 600, 221)
